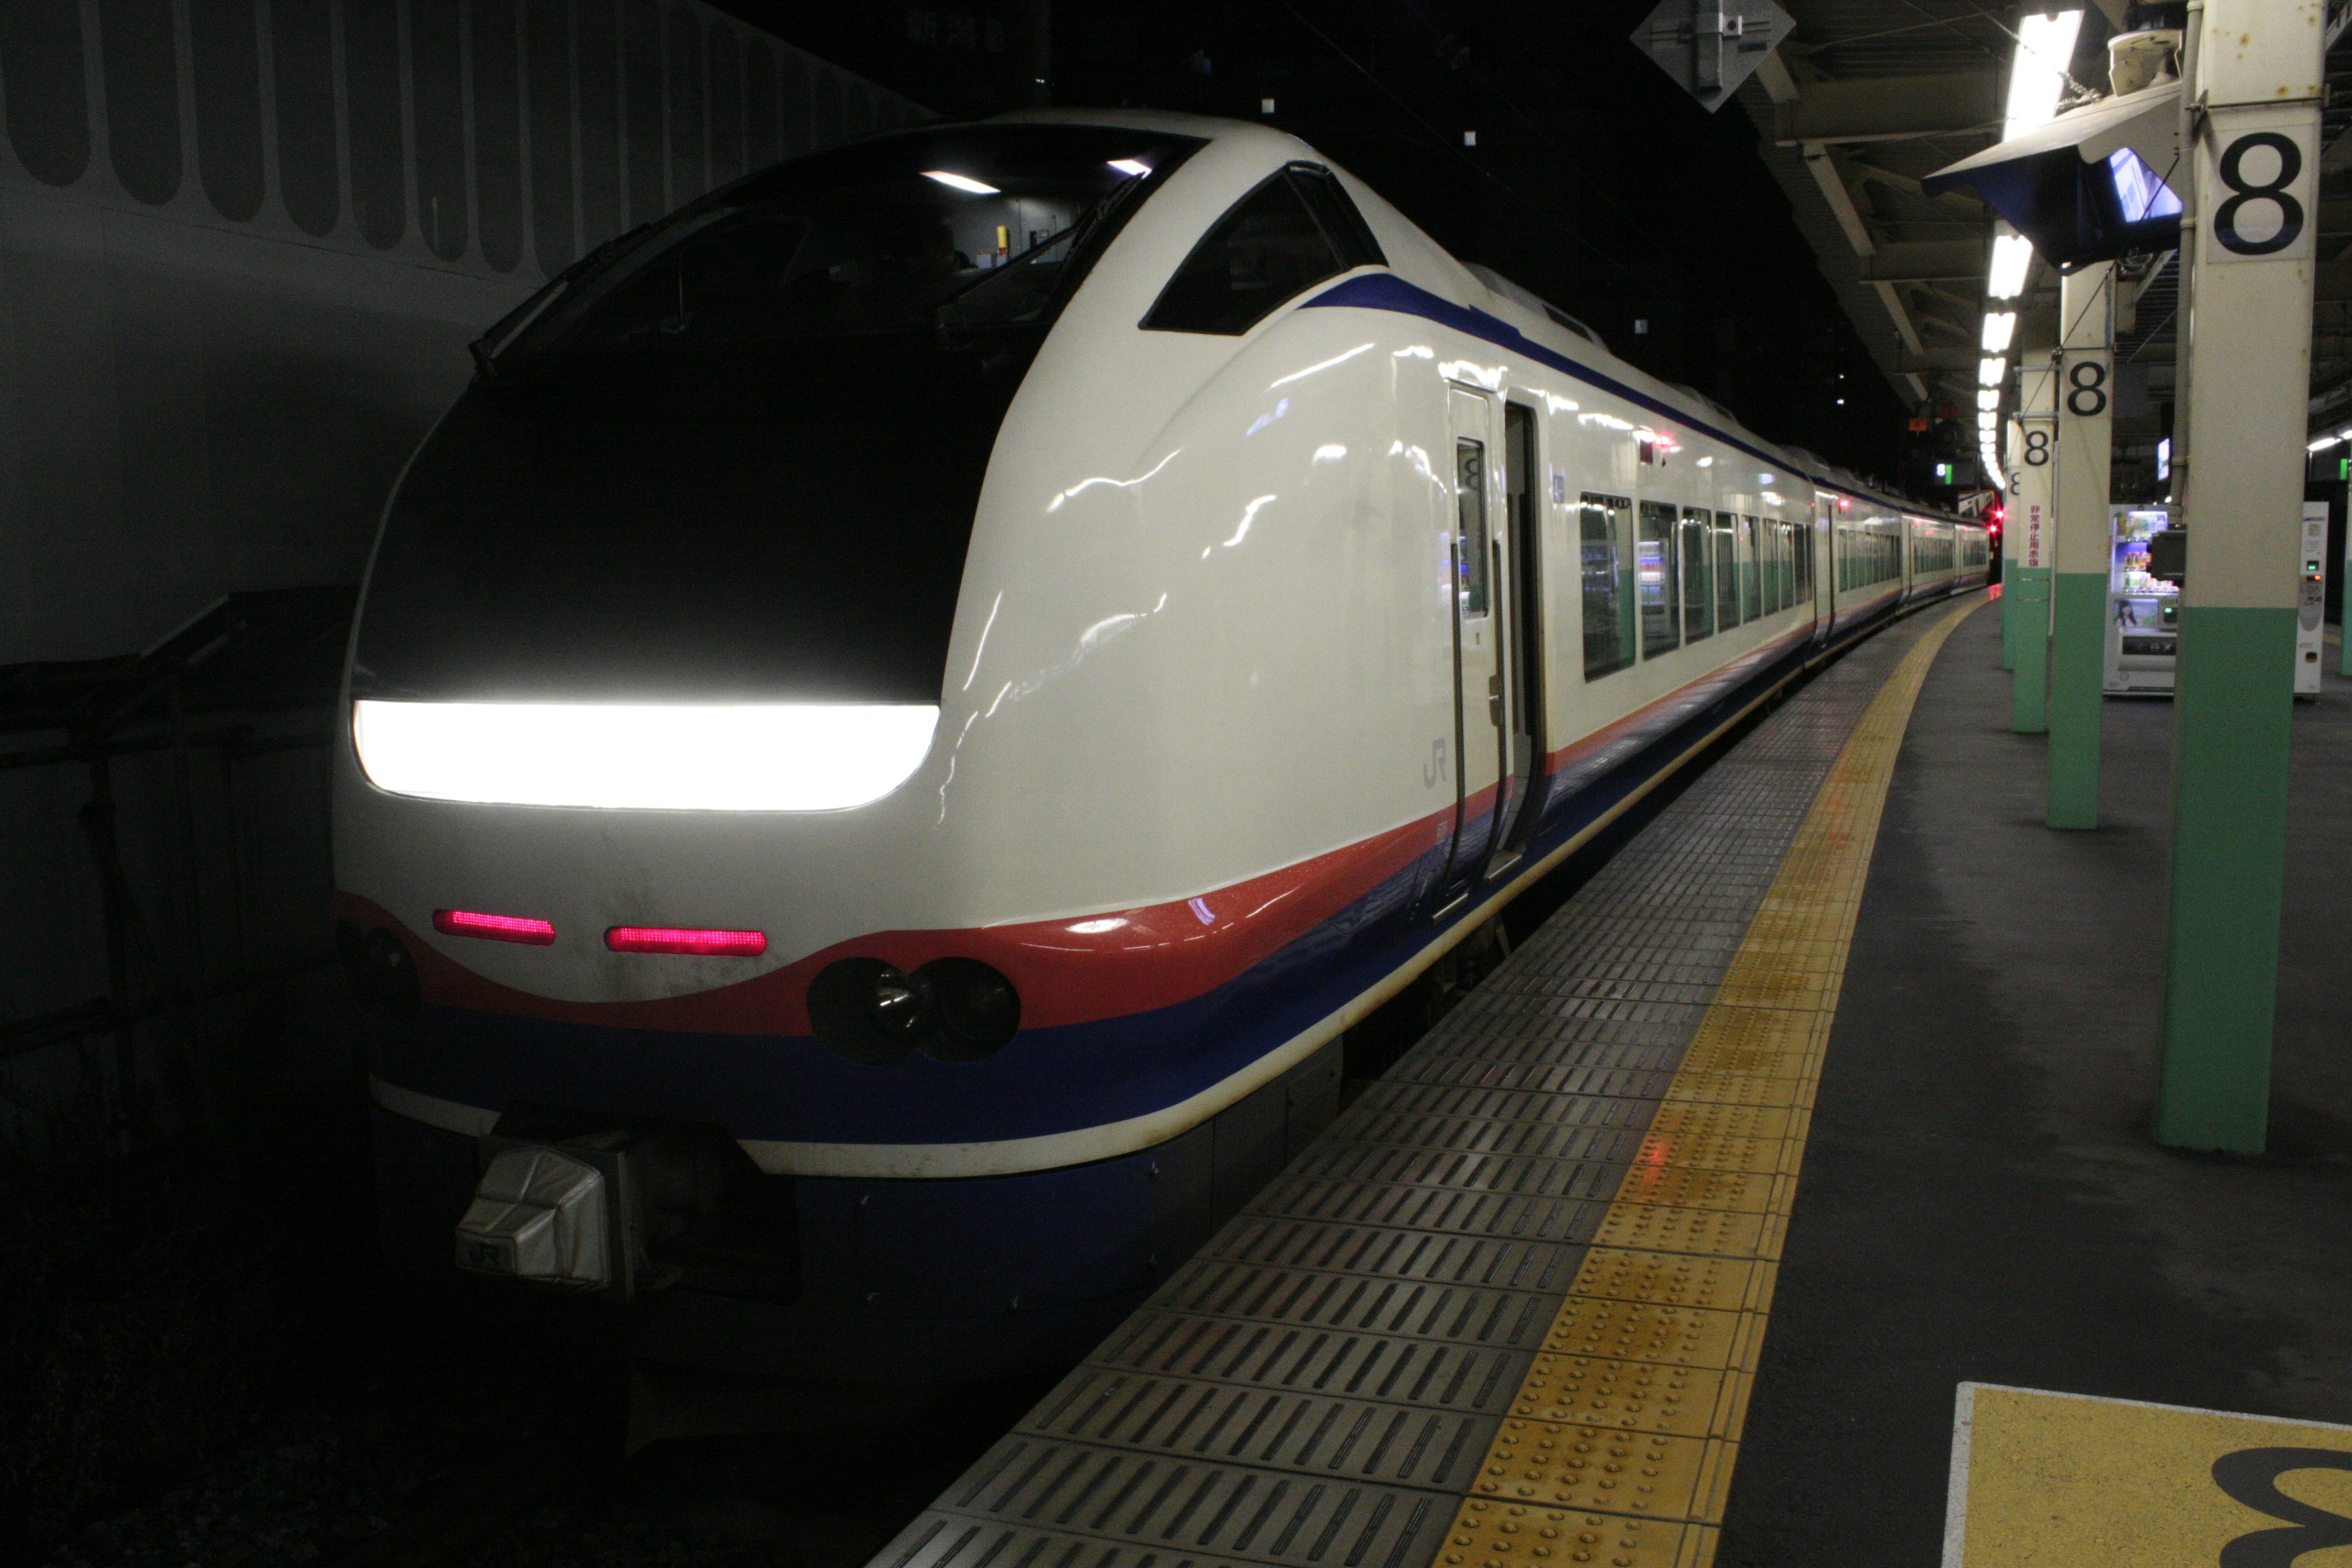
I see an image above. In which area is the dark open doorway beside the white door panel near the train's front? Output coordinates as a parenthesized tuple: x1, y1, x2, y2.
(1487, 402, 1543, 875)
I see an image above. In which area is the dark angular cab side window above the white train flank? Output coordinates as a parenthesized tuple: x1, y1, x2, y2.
(1143, 165, 1385, 336)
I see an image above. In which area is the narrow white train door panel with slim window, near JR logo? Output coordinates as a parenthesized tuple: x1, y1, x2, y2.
(1434, 388, 1510, 917)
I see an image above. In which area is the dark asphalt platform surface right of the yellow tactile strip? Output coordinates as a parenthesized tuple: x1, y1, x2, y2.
(1717, 609, 2352, 1568)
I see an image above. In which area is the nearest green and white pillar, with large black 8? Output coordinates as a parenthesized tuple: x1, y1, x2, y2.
(2157, 0, 2324, 1154)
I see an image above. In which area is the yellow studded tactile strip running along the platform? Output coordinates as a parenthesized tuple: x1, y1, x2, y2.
(1439, 600, 1983, 1568)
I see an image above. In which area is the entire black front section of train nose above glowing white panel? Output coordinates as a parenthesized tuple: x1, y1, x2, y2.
(350, 124, 1197, 703)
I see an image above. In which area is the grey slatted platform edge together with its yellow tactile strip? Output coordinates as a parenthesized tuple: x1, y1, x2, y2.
(875, 601, 1985, 1568)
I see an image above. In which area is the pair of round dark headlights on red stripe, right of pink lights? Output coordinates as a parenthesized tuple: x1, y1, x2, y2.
(809, 959, 1021, 1065)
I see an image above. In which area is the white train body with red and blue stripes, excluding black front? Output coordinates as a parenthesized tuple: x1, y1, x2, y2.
(336, 110, 1985, 1378)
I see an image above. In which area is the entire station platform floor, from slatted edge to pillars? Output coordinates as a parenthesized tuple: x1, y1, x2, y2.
(873, 597, 2352, 1568)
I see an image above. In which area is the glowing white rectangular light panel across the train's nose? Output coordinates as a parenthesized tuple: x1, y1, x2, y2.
(350, 701, 938, 811)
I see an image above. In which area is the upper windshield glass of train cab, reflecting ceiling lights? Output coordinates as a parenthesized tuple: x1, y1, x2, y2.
(492, 124, 1199, 364)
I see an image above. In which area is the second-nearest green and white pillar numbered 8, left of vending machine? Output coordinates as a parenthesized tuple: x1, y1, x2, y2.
(2049, 261, 2114, 827)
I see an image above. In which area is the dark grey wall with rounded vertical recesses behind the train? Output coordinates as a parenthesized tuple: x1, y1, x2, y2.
(0, 0, 924, 663)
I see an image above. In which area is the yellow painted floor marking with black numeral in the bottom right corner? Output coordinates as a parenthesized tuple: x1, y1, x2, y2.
(1943, 1382, 2352, 1568)
